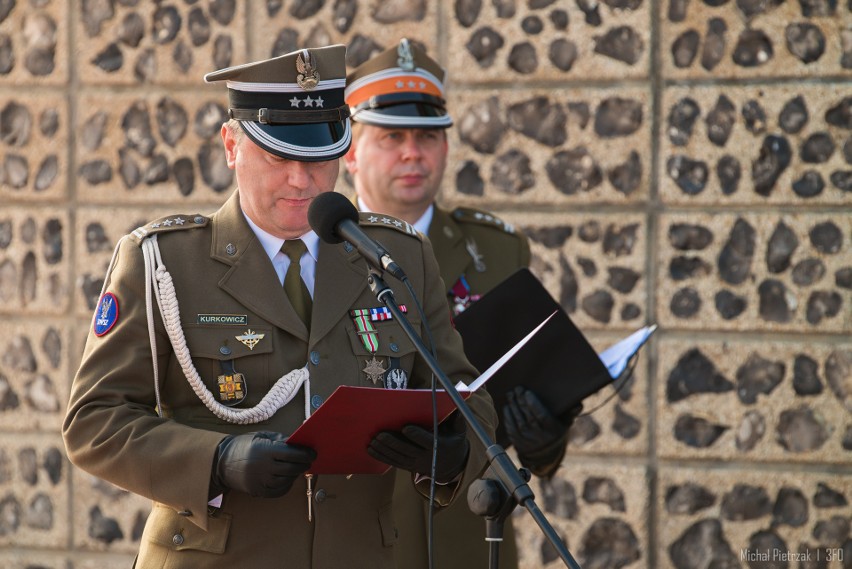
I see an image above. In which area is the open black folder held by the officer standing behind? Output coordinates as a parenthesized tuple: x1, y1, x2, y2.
(455, 269, 613, 447)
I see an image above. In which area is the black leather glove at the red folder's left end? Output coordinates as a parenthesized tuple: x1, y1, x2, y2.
(210, 432, 317, 498)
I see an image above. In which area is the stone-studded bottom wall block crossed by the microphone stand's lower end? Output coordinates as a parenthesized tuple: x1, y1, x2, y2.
(512, 460, 650, 569)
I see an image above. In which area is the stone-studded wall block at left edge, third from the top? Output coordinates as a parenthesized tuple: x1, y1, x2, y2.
(0, 206, 71, 315)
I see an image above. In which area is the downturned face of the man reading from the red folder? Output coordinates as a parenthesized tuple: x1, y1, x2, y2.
(221, 124, 340, 239)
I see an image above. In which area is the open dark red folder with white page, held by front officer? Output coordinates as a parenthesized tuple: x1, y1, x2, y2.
(287, 308, 553, 474)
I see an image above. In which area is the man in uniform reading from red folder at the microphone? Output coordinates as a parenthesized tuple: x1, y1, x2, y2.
(63, 45, 496, 569)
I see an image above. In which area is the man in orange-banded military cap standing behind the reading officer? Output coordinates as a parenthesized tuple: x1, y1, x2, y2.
(344, 39, 580, 569)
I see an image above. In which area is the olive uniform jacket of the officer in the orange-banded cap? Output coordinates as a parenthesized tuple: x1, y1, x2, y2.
(394, 207, 530, 569)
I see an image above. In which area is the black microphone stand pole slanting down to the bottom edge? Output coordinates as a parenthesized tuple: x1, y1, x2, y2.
(367, 268, 581, 569)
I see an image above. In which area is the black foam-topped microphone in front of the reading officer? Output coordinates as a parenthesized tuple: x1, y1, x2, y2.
(308, 191, 407, 281)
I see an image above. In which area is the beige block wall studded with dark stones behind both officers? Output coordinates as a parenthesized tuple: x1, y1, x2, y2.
(0, 0, 852, 569)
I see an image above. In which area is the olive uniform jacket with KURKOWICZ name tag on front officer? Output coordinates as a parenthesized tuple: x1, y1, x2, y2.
(63, 192, 496, 569)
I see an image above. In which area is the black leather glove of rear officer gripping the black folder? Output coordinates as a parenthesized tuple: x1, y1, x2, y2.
(503, 386, 583, 478)
